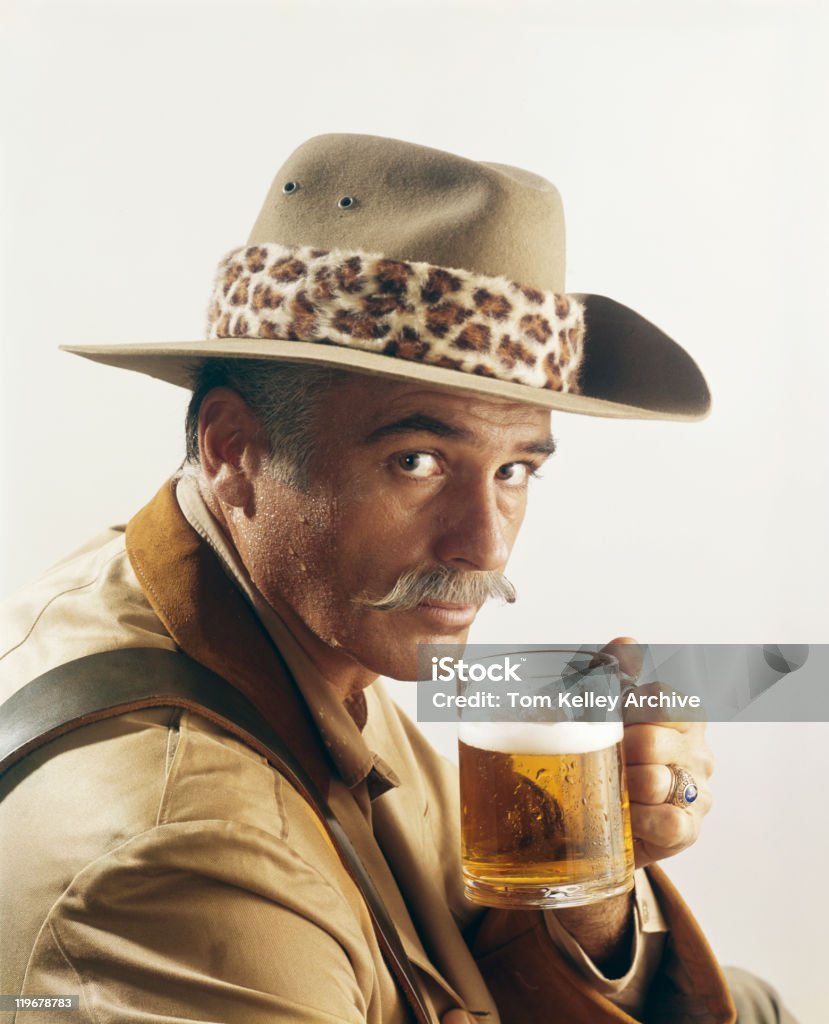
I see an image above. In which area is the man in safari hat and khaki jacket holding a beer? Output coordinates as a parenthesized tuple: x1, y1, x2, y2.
(0, 135, 790, 1024)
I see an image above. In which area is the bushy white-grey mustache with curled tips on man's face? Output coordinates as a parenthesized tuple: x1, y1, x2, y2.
(355, 565, 518, 611)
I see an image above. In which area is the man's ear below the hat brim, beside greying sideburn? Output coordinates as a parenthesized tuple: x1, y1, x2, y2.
(199, 387, 267, 515)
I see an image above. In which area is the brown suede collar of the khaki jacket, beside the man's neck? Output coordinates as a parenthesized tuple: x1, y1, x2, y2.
(126, 480, 333, 795)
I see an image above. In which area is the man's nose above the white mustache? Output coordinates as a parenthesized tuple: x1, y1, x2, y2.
(435, 482, 510, 571)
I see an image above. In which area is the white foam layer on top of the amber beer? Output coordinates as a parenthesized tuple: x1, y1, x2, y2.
(457, 722, 624, 754)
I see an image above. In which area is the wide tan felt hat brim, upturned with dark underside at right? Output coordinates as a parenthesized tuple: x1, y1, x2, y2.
(60, 294, 710, 421)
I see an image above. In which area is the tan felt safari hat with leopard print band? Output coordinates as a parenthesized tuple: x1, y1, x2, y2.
(66, 134, 710, 420)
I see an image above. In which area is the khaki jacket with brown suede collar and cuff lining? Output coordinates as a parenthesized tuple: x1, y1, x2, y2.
(0, 484, 734, 1024)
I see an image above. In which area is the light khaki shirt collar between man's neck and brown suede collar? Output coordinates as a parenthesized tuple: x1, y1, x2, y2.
(176, 471, 399, 800)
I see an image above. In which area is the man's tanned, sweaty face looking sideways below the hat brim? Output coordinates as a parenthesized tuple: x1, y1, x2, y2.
(235, 375, 553, 679)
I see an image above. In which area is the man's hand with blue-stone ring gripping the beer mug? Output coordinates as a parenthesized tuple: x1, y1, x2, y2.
(603, 637, 713, 867)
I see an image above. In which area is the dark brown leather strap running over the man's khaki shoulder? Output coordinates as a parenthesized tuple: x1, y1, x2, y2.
(0, 647, 434, 1024)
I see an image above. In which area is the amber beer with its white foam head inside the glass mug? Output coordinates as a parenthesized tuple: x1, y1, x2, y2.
(459, 722, 634, 906)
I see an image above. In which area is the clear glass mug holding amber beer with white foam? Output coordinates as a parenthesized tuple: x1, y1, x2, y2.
(459, 648, 634, 907)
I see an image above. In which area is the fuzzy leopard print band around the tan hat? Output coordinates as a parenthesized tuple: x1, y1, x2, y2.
(208, 243, 584, 394)
